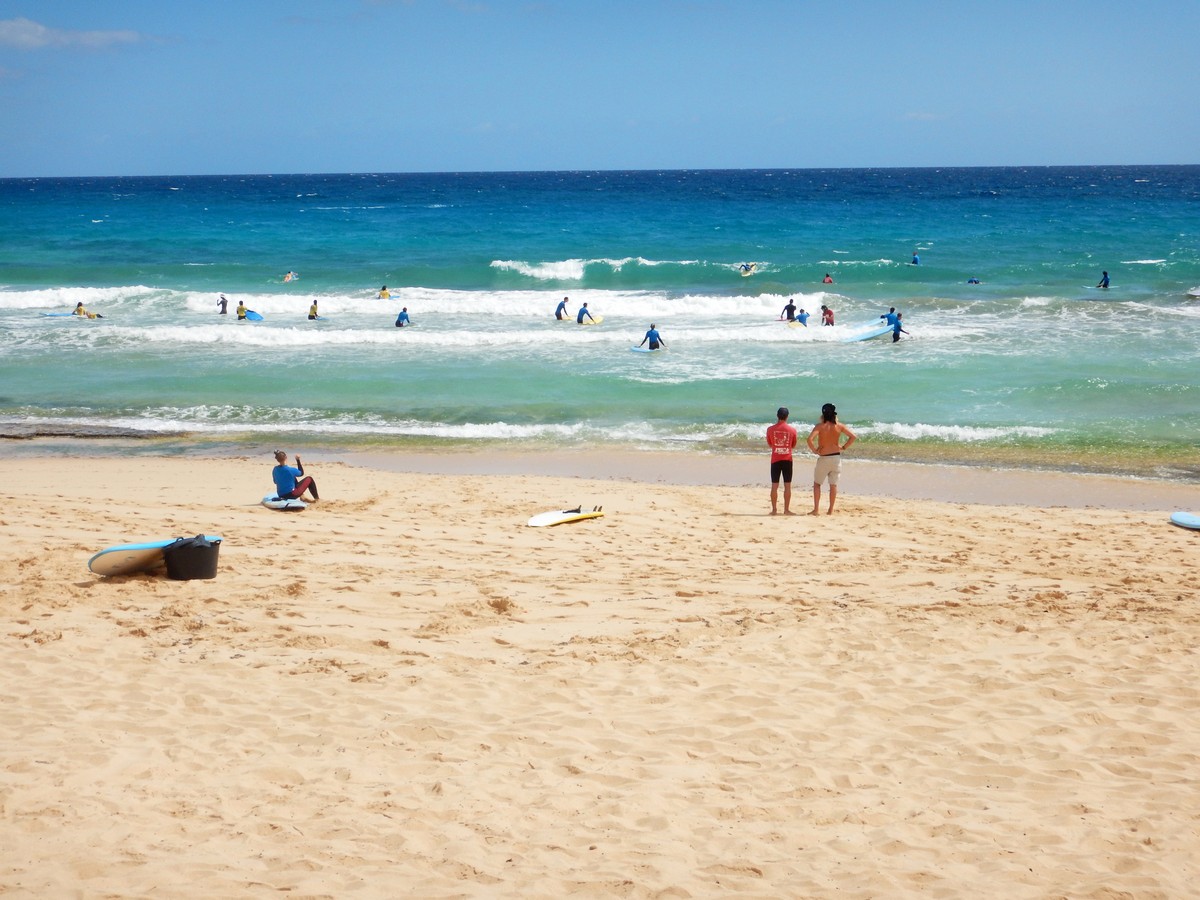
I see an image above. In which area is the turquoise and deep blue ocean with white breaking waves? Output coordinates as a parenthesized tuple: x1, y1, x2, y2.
(0, 166, 1200, 482)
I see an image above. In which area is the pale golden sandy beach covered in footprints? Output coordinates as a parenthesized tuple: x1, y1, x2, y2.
(0, 449, 1200, 898)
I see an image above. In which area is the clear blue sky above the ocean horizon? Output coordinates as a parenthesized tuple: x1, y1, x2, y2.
(0, 0, 1200, 178)
